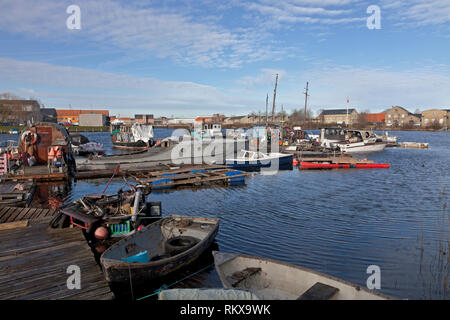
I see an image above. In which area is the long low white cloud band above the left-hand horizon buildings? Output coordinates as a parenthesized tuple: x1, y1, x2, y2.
(0, 58, 256, 114)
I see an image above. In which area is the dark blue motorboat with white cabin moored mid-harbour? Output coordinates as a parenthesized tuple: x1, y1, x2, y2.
(226, 150, 294, 169)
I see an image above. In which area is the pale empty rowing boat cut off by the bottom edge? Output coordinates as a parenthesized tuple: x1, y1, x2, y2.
(213, 251, 390, 300)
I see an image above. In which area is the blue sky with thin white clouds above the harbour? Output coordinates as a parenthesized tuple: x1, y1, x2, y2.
(0, 0, 450, 117)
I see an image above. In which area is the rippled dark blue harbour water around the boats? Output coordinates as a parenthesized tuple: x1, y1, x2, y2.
(0, 129, 450, 299)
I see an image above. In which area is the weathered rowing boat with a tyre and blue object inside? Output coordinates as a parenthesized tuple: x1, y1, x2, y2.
(100, 215, 219, 283)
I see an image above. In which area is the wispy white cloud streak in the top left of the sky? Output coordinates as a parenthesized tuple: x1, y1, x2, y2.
(0, 0, 279, 68)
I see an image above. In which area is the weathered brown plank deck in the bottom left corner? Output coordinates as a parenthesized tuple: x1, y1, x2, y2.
(0, 208, 114, 300)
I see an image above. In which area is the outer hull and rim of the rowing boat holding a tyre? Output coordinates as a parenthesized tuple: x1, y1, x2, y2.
(100, 217, 219, 283)
